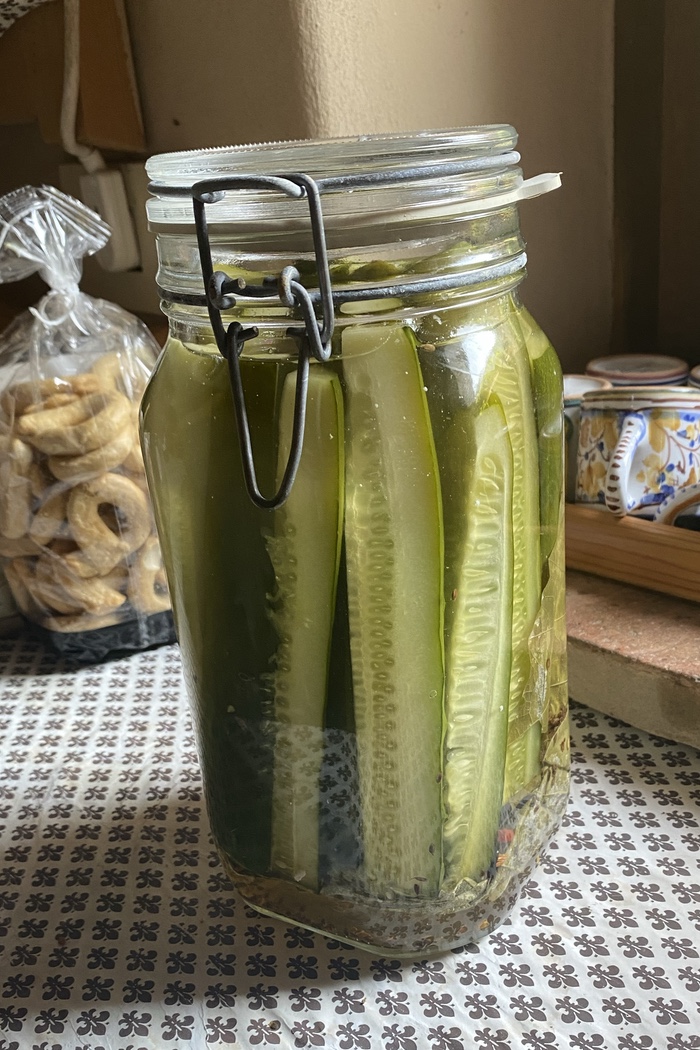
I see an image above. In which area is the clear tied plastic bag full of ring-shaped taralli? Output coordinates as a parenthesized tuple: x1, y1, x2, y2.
(0, 187, 173, 662)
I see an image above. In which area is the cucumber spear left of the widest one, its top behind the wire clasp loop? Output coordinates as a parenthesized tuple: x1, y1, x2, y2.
(269, 368, 344, 889)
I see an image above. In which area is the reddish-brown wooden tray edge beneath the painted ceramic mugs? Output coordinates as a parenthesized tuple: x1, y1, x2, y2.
(567, 503, 700, 602)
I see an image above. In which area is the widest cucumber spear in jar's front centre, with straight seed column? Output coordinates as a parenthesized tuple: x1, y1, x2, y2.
(342, 324, 444, 899)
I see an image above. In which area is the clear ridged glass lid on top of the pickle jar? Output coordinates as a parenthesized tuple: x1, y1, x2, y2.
(146, 124, 523, 227)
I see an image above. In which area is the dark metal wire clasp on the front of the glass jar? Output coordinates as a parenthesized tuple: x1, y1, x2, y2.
(192, 173, 335, 510)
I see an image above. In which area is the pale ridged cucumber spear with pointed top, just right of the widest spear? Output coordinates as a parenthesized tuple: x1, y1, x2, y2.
(444, 398, 513, 890)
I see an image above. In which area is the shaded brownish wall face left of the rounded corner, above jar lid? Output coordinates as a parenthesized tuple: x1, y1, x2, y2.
(126, 0, 310, 153)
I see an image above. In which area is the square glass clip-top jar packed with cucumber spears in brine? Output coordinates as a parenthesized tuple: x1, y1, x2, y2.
(142, 126, 569, 957)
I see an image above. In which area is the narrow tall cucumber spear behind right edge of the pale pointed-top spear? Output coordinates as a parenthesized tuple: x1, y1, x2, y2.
(492, 326, 542, 801)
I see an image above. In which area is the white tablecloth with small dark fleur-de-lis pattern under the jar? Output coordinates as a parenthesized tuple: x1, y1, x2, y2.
(0, 641, 700, 1050)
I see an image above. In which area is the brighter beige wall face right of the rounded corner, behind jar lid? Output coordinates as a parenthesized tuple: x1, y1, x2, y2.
(295, 0, 614, 371)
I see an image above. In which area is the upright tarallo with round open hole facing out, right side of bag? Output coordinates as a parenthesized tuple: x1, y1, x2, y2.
(66, 474, 151, 574)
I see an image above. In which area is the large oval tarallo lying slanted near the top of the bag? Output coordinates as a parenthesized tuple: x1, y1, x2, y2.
(17, 391, 131, 456)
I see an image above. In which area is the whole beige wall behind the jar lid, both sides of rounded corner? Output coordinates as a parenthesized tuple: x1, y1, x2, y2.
(0, 0, 617, 371)
